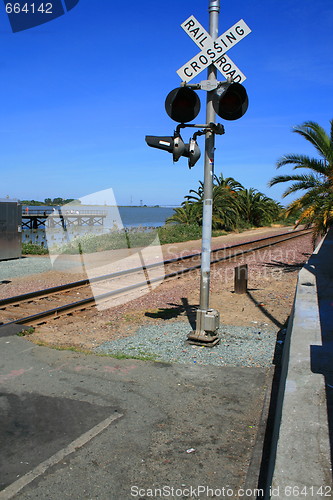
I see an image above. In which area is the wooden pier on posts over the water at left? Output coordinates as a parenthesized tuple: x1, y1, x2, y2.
(22, 210, 107, 229)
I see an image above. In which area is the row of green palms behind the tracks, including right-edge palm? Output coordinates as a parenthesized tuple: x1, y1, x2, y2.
(167, 120, 333, 241)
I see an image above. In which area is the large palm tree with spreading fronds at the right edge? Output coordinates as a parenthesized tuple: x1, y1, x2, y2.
(269, 120, 333, 240)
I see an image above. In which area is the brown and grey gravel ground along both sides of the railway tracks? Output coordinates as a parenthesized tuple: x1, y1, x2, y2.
(0, 228, 312, 367)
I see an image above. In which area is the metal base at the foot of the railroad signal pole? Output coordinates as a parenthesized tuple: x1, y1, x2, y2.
(187, 309, 220, 347)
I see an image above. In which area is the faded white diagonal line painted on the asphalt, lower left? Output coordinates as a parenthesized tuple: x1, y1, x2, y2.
(0, 413, 123, 500)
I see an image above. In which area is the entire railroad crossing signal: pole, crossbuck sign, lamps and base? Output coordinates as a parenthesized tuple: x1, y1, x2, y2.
(146, 0, 251, 347)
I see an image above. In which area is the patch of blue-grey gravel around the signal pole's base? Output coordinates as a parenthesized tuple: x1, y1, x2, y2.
(94, 321, 281, 367)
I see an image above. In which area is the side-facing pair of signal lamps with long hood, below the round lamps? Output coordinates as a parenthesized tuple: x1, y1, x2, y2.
(146, 132, 201, 168)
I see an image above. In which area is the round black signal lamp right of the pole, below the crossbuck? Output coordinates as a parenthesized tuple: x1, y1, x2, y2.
(213, 83, 249, 120)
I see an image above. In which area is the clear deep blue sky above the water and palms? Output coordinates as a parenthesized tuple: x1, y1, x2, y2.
(0, 0, 333, 205)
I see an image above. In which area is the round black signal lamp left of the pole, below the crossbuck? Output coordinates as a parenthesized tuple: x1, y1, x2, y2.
(165, 87, 200, 123)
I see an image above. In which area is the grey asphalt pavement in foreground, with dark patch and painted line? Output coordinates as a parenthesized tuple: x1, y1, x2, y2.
(0, 326, 273, 500)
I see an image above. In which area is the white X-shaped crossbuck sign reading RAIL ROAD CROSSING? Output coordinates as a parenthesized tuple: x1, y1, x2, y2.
(177, 16, 251, 83)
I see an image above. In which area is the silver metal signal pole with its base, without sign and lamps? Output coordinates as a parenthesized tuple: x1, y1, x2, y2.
(188, 0, 220, 346)
